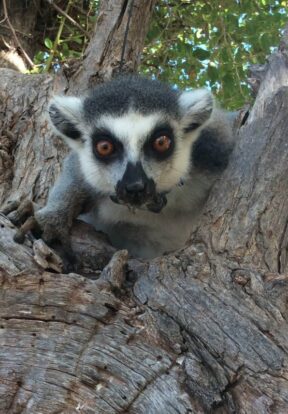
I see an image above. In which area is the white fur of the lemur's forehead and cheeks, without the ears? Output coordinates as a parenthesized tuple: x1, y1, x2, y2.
(78, 111, 207, 195)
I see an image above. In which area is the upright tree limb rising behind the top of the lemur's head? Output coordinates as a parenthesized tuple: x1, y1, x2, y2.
(69, 0, 156, 94)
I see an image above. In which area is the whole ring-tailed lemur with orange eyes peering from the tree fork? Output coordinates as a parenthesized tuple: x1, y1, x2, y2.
(35, 76, 233, 258)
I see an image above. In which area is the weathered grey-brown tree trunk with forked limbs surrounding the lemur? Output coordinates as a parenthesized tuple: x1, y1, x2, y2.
(0, 0, 288, 414)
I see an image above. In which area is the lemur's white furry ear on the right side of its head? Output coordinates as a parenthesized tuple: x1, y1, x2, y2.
(179, 89, 214, 133)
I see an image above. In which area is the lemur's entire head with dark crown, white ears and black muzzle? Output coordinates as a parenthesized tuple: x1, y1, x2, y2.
(49, 76, 213, 212)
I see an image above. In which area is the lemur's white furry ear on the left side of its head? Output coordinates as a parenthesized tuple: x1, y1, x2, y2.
(48, 96, 83, 148)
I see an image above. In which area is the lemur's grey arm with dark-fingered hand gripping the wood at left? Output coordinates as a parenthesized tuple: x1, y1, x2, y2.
(1, 152, 97, 254)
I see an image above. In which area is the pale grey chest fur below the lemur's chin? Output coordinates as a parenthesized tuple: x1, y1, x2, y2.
(85, 175, 211, 258)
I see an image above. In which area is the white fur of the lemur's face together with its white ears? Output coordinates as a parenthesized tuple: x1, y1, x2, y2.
(48, 90, 213, 195)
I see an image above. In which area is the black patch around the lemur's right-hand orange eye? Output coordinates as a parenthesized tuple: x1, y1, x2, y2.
(143, 123, 175, 161)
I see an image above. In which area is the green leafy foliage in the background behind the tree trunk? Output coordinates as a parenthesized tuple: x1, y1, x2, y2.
(34, 0, 288, 109)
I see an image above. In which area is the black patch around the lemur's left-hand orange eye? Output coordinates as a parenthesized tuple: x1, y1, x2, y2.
(91, 128, 123, 164)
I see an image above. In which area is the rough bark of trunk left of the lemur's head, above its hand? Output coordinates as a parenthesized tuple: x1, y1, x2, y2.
(0, 69, 60, 204)
